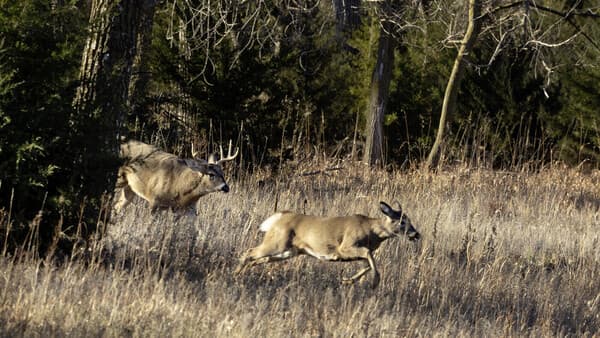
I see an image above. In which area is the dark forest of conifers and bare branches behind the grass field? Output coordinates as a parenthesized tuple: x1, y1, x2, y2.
(0, 0, 600, 251)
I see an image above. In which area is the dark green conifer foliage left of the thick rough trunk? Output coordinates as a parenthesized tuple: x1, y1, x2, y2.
(0, 0, 83, 251)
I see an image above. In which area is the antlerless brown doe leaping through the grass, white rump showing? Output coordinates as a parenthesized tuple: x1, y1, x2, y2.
(235, 202, 421, 287)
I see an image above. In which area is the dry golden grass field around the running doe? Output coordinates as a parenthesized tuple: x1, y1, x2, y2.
(0, 164, 600, 337)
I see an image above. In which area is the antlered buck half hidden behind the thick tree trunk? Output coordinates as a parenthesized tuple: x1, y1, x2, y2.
(115, 141, 239, 212)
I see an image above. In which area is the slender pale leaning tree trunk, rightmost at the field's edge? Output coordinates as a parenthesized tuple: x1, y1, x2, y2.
(425, 0, 481, 168)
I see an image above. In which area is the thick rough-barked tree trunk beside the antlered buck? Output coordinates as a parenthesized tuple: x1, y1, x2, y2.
(71, 0, 157, 224)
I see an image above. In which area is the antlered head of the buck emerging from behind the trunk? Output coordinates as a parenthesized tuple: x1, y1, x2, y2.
(191, 141, 239, 192)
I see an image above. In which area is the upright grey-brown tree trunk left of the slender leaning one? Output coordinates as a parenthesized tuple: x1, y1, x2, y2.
(363, 15, 394, 165)
